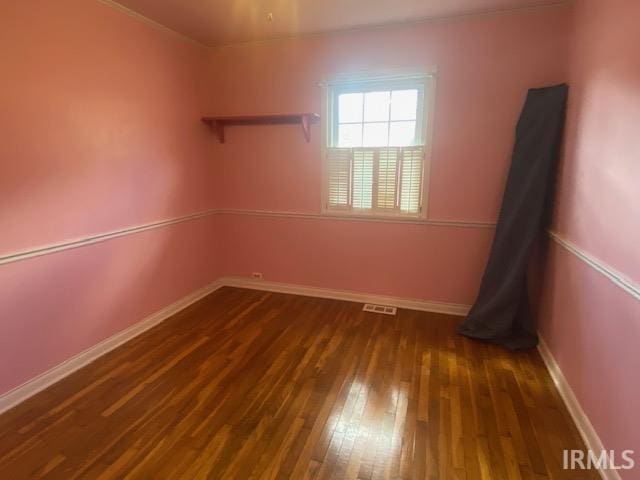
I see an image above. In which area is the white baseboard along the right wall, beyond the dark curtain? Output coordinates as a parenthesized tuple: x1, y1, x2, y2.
(538, 338, 620, 480)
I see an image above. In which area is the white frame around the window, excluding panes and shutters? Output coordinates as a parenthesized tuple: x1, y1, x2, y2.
(320, 67, 437, 220)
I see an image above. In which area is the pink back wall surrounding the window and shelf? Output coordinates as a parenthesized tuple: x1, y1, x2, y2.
(209, 7, 570, 304)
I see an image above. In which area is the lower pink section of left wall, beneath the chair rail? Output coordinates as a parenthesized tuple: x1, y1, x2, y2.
(0, 218, 218, 394)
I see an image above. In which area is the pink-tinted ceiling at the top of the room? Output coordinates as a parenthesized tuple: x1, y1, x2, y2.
(112, 0, 561, 46)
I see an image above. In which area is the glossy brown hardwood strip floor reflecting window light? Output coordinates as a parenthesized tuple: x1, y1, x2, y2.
(0, 288, 599, 480)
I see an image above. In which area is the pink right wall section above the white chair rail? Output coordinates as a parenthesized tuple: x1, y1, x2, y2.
(554, 0, 640, 283)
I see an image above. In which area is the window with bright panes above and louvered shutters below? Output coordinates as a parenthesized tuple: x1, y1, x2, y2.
(323, 70, 433, 217)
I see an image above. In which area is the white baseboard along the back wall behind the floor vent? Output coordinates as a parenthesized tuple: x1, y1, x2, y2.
(219, 277, 471, 316)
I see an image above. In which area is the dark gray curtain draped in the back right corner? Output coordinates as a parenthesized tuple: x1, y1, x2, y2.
(458, 84, 568, 349)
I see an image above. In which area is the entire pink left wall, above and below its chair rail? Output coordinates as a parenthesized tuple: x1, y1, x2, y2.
(0, 0, 217, 394)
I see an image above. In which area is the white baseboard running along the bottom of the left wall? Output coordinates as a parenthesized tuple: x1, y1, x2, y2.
(0, 281, 222, 413)
